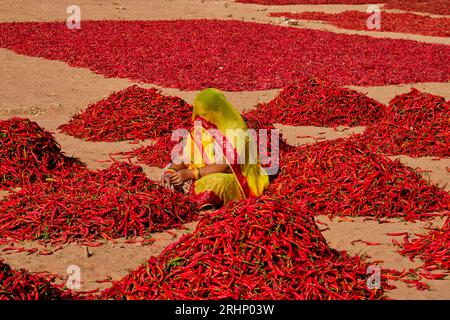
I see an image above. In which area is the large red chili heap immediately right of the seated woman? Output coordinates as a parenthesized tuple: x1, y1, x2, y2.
(267, 137, 450, 220)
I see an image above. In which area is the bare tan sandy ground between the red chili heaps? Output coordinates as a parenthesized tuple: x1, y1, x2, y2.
(0, 0, 450, 299)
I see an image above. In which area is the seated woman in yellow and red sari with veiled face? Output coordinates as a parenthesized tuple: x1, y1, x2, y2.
(161, 88, 269, 208)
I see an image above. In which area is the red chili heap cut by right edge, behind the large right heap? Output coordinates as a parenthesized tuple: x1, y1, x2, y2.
(360, 89, 450, 157)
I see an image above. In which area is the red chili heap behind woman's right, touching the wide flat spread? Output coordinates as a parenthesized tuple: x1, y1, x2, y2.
(244, 77, 385, 127)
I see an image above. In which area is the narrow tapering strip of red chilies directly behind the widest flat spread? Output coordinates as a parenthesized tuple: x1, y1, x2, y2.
(270, 11, 450, 37)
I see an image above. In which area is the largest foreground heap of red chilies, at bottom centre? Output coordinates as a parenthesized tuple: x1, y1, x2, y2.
(98, 196, 383, 300)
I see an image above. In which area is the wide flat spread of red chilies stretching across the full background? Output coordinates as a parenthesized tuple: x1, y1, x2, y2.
(0, 19, 450, 91)
